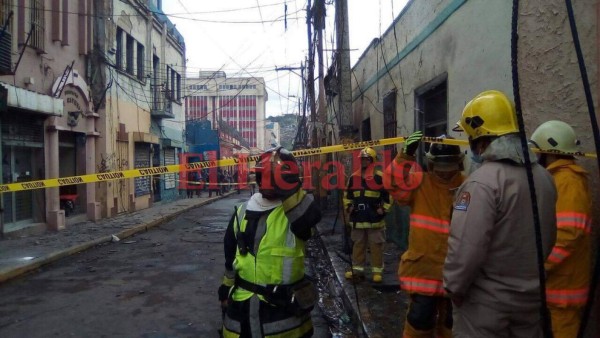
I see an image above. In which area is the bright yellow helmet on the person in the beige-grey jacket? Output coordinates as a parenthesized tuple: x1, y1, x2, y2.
(452, 90, 519, 140)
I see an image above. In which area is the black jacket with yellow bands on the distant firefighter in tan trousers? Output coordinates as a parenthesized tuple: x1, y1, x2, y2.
(344, 169, 392, 229)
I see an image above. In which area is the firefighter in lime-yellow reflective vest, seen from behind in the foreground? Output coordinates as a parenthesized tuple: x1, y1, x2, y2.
(218, 147, 321, 337)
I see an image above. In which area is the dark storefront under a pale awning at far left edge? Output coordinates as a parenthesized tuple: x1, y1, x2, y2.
(0, 83, 63, 233)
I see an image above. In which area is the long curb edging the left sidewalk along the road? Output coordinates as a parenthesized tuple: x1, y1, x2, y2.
(0, 193, 231, 284)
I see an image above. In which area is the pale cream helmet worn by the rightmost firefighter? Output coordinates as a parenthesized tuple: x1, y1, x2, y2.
(531, 120, 579, 153)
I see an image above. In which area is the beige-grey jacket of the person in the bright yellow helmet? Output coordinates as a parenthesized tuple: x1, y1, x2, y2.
(443, 149, 556, 313)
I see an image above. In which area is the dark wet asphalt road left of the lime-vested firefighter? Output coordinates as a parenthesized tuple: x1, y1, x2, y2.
(0, 195, 330, 338)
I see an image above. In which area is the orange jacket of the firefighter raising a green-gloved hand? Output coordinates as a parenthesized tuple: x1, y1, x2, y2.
(384, 154, 464, 296)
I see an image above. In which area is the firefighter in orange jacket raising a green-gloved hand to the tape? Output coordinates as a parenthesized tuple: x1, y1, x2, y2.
(384, 131, 465, 338)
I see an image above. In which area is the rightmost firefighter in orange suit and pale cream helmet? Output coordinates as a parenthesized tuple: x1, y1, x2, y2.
(531, 121, 592, 338)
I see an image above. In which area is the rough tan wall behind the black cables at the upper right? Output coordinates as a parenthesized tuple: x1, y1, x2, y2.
(519, 0, 600, 224)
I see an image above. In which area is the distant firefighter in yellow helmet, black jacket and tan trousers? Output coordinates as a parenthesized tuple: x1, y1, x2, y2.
(344, 147, 391, 283)
